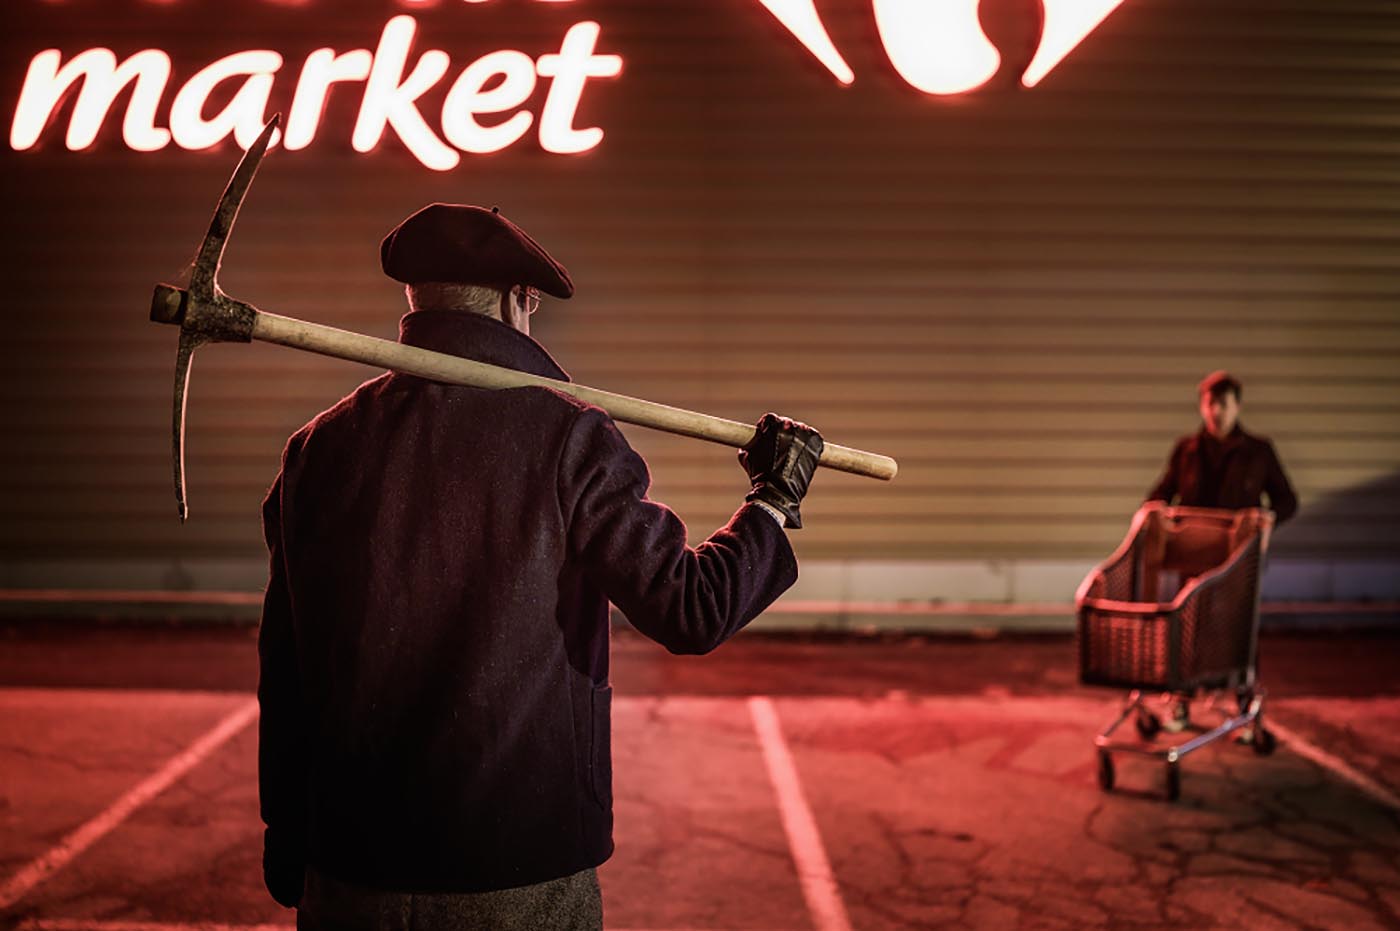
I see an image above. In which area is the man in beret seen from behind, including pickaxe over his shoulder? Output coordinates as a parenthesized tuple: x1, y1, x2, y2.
(151, 118, 897, 931)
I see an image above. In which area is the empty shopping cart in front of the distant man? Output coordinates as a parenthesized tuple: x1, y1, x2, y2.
(1075, 501, 1274, 801)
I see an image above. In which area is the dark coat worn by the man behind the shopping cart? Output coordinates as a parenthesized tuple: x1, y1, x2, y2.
(1147, 427, 1298, 524)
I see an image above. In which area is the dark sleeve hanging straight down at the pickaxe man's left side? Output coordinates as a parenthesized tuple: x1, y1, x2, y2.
(258, 450, 307, 909)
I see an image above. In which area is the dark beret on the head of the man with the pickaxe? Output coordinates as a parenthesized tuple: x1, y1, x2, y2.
(379, 203, 574, 298)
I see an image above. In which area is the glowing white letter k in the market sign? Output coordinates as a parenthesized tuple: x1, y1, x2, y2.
(350, 15, 461, 171)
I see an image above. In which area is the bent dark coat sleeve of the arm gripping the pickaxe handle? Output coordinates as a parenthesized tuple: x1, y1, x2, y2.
(559, 407, 797, 654)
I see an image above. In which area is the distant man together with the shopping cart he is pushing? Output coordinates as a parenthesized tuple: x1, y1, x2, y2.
(1075, 371, 1298, 799)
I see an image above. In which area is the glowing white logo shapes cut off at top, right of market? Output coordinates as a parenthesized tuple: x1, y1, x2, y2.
(757, 0, 1124, 95)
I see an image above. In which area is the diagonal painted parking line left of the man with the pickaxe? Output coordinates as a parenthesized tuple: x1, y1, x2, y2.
(0, 699, 258, 907)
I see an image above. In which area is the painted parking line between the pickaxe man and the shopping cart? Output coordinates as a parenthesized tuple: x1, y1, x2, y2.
(749, 696, 851, 931)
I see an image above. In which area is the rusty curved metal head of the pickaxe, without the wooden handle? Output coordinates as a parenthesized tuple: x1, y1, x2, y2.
(151, 113, 281, 522)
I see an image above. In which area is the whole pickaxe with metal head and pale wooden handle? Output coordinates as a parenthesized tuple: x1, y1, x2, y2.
(151, 115, 899, 521)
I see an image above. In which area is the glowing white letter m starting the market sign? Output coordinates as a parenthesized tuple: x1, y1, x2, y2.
(10, 49, 171, 153)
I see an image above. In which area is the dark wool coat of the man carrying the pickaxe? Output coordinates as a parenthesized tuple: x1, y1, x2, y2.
(258, 311, 797, 892)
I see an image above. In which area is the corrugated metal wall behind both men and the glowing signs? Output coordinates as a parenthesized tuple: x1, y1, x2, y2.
(0, 0, 1400, 560)
